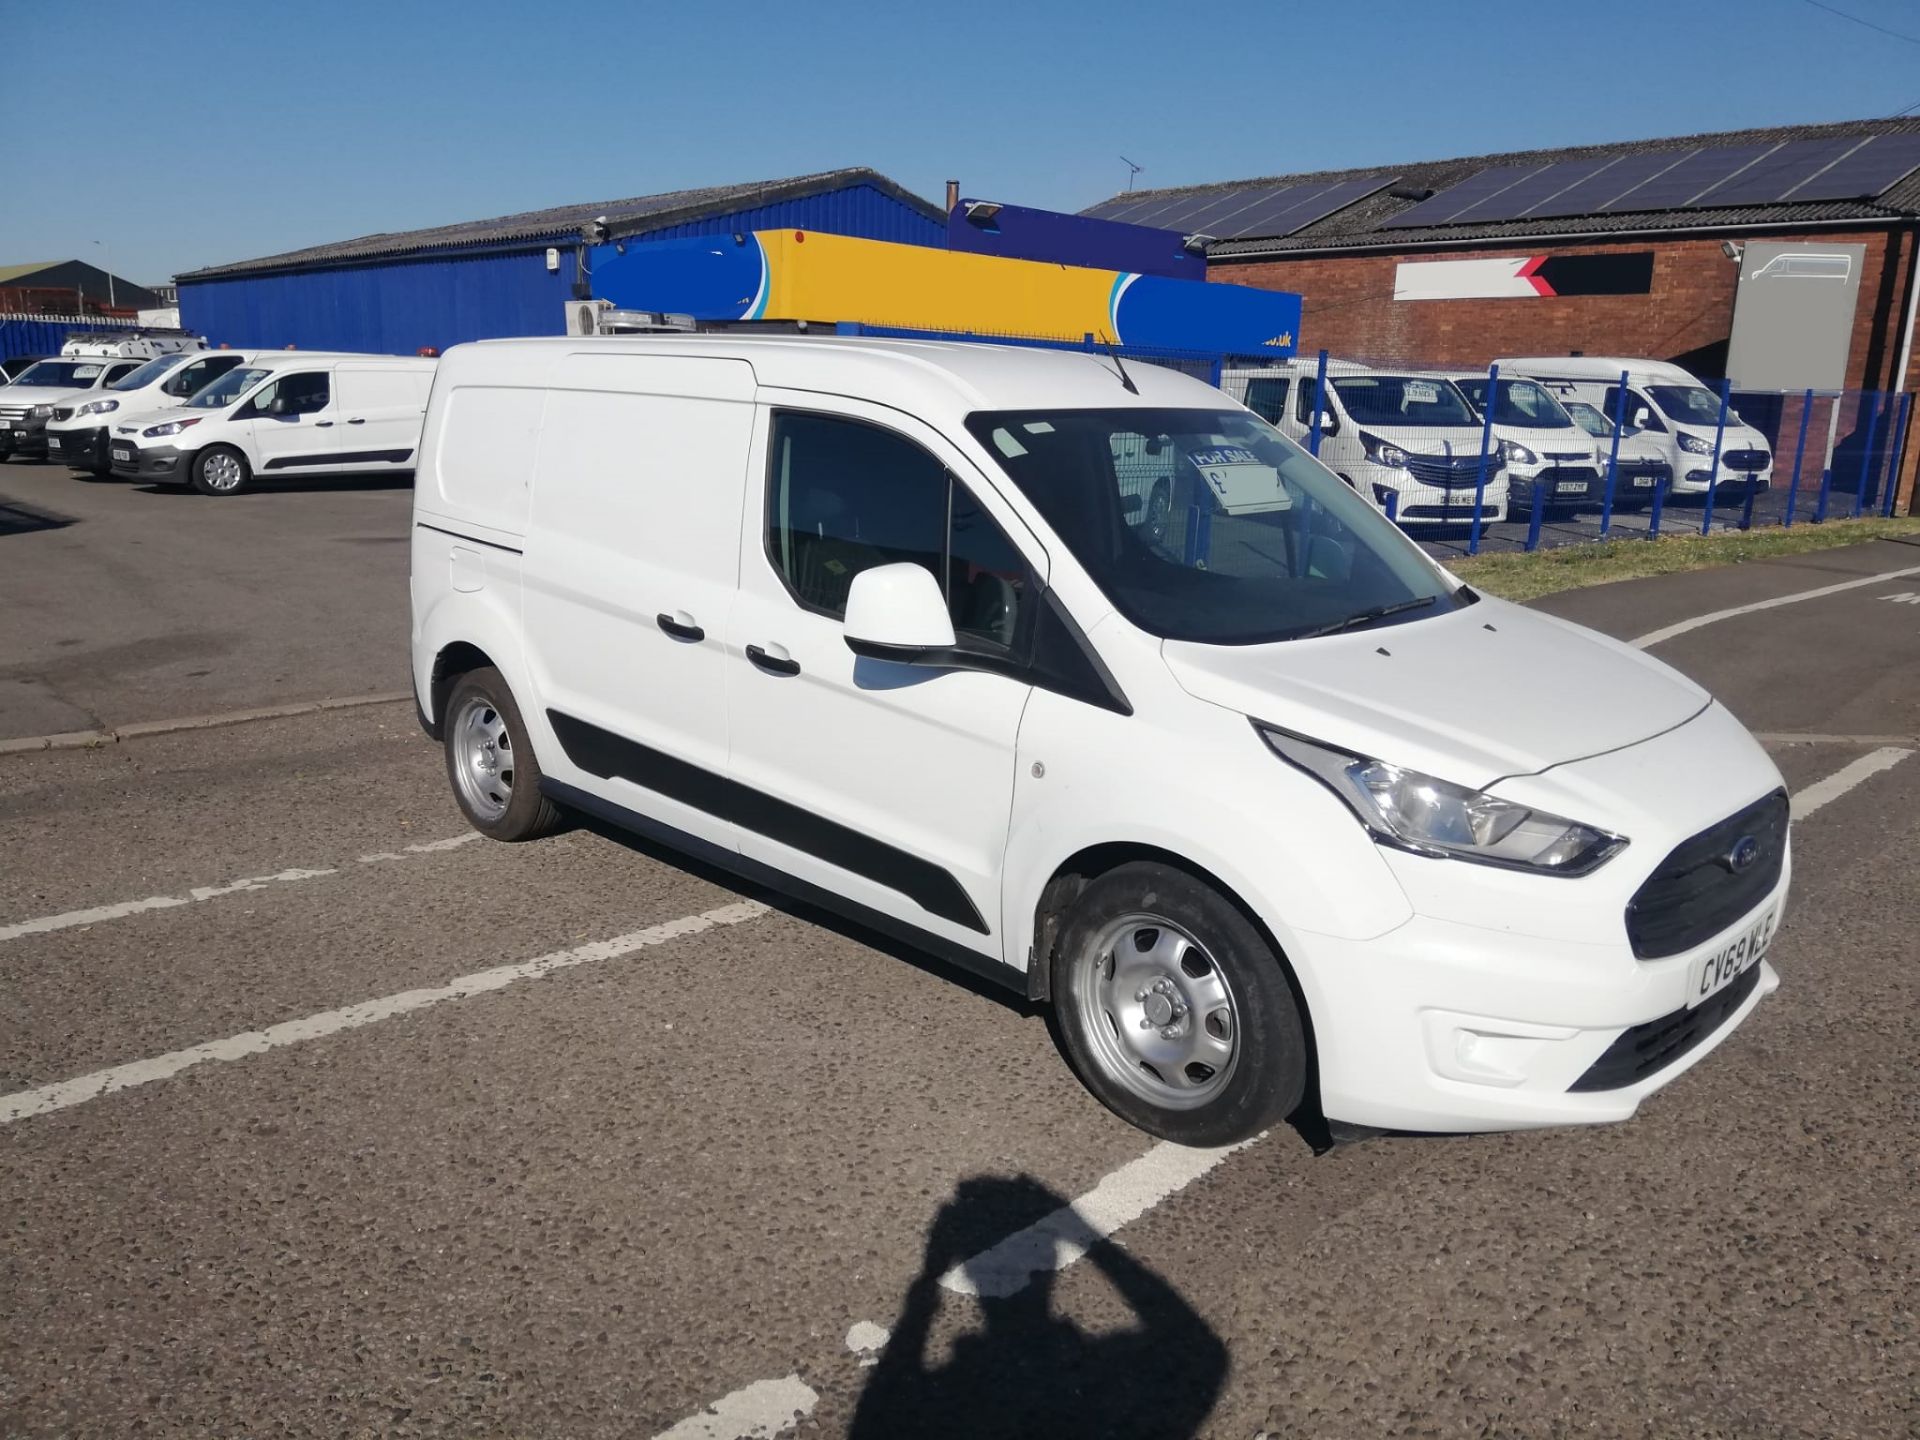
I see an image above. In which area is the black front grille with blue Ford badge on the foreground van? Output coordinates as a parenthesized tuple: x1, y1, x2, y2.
(1626, 789, 1788, 960)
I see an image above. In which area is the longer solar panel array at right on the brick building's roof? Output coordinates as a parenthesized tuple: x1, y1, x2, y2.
(1380, 132, 1920, 230)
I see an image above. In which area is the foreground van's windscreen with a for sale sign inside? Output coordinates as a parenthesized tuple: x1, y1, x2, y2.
(968, 403, 1475, 645)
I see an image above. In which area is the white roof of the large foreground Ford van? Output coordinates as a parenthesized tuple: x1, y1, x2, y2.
(453, 334, 1233, 413)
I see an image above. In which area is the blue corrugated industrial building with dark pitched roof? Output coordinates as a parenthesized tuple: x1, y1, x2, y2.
(177, 169, 947, 355)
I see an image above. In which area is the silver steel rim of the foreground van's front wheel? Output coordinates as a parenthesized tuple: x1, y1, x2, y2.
(1073, 912, 1240, 1110)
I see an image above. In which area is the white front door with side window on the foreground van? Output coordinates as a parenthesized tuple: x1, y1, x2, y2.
(728, 390, 1046, 960)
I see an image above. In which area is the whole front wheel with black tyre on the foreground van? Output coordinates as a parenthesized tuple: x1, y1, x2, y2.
(1052, 862, 1308, 1146)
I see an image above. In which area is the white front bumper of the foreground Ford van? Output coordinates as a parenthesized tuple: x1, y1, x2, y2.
(1296, 862, 1791, 1131)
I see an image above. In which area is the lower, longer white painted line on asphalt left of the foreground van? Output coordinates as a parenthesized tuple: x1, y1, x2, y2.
(0, 900, 766, 1125)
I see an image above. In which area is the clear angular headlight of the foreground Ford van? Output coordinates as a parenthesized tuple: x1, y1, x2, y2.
(1254, 722, 1626, 876)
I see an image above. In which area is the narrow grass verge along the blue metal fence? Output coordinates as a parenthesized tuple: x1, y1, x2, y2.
(1448, 515, 1920, 601)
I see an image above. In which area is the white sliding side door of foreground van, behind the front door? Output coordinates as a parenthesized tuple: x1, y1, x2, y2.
(520, 355, 753, 851)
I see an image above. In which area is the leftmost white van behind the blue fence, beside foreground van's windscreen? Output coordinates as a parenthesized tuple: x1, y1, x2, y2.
(1221, 361, 1507, 526)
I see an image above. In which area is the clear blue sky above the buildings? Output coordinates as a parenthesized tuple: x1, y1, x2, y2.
(0, 0, 1920, 280)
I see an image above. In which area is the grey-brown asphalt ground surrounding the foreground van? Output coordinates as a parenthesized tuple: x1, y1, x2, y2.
(0, 467, 1920, 1440)
